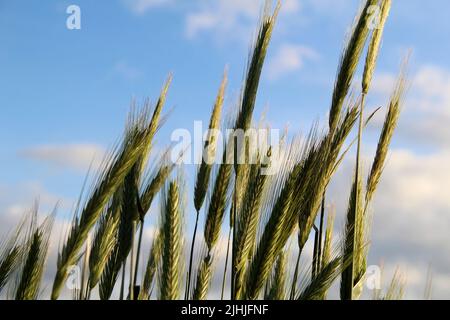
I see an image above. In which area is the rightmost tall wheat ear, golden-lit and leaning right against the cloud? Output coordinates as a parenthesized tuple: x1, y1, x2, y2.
(364, 65, 407, 211)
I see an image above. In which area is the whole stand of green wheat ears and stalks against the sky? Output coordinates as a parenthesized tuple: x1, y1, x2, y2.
(0, 0, 412, 300)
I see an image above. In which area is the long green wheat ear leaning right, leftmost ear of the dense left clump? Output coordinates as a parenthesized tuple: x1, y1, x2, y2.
(51, 109, 155, 299)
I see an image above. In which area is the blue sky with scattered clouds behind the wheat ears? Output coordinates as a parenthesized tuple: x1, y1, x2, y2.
(0, 0, 450, 298)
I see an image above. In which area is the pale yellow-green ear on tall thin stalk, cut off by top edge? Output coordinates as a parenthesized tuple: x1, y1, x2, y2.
(362, 0, 392, 94)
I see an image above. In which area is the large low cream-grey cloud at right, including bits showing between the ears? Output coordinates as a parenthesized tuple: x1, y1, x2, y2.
(328, 148, 450, 299)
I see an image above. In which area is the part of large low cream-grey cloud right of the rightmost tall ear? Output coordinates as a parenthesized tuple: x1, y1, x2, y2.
(372, 150, 450, 298)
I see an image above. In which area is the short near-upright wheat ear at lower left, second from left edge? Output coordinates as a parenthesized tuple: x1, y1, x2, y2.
(15, 207, 56, 300)
